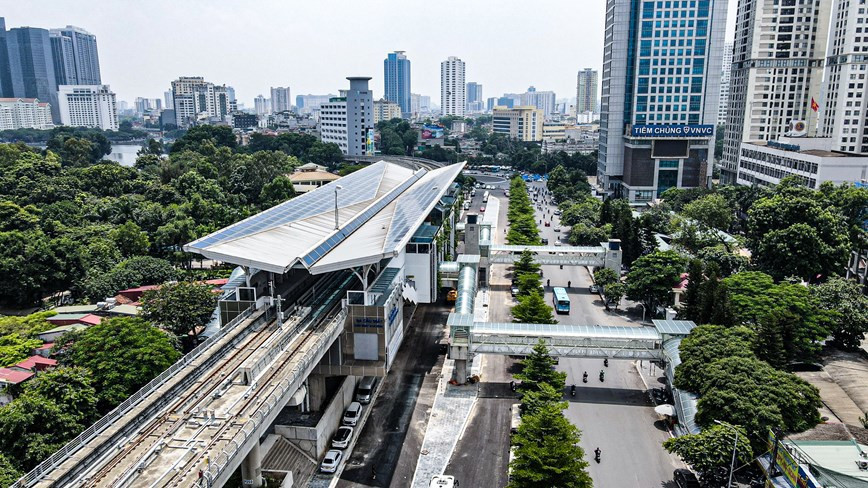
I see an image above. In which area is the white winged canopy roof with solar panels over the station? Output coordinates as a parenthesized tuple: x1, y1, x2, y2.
(184, 161, 464, 274)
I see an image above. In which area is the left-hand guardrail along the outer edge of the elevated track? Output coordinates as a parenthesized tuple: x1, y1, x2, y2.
(10, 306, 254, 488)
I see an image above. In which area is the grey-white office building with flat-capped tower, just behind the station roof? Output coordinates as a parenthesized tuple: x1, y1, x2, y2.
(319, 77, 374, 156)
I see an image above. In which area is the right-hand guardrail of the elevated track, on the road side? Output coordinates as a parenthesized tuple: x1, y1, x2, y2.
(199, 309, 348, 487)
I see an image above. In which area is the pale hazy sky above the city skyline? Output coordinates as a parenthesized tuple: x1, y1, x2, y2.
(0, 0, 737, 107)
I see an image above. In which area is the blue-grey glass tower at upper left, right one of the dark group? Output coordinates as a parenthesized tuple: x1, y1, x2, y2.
(49, 25, 102, 86)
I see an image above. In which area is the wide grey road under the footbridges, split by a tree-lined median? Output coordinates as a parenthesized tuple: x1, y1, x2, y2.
(446, 183, 681, 488)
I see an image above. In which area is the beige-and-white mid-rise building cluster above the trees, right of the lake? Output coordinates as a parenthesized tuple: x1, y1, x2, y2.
(172, 76, 230, 127)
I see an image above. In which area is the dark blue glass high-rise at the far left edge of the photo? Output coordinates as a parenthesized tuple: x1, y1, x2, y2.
(6, 23, 60, 122)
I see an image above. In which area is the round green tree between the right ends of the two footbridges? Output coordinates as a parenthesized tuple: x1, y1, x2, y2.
(627, 251, 685, 316)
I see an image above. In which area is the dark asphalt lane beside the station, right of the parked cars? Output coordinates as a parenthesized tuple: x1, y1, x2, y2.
(337, 304, 448, 488)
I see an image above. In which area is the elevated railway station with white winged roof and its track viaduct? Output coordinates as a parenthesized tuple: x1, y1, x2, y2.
(20, 158, 464, 487)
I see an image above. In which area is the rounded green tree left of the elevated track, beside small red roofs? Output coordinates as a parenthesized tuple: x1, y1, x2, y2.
(63, 318, 180, 412)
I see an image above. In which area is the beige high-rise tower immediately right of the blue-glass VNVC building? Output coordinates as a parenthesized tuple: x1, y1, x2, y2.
(720, 0, 836, 183)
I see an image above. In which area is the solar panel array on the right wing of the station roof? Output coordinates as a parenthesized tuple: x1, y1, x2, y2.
(383, 165, 461, 253)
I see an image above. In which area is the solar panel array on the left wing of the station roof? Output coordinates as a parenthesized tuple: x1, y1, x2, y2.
(187, 162, 386, 249)
